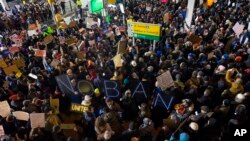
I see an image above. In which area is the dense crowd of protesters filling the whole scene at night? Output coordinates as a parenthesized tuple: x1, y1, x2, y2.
(0, 0, 250, 141)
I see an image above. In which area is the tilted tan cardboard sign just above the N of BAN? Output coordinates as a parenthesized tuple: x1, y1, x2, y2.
(156, 71, 174, 91)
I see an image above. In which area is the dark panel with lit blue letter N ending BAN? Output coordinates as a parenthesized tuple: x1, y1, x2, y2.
(153, 91, 174, 110)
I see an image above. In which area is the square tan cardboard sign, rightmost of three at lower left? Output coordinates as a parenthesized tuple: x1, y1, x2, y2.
(30, 113, 45, 129)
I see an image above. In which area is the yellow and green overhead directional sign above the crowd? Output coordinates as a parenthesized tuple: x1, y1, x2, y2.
(128, 22, 161, 40)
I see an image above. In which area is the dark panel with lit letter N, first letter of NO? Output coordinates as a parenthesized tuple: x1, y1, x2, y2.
(56, 75, 75, 95)
